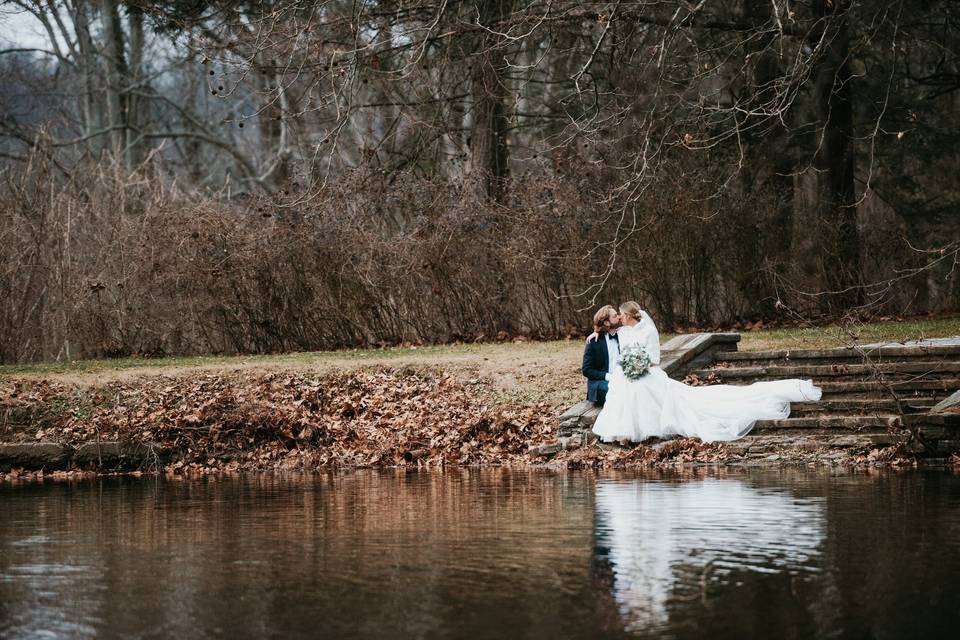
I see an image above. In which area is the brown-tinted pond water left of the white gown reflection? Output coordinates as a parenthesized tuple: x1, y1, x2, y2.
(0, 469, 616, 637)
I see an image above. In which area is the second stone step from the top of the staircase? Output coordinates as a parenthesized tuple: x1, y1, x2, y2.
(691, 360, 960, 383)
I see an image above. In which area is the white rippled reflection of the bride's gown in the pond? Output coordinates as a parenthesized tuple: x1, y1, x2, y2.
(596, 479, 826, 631)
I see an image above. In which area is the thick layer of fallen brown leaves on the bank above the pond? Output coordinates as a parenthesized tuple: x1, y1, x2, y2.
(0, 368, 752, 473)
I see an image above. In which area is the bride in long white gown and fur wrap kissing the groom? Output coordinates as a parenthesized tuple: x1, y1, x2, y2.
(588, 302, 820, 442)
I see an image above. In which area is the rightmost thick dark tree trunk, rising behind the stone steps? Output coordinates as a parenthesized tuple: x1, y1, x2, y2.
(813, 0, 861, 314)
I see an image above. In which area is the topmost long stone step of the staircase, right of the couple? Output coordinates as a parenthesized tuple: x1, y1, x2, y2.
(717, 344, 960, 366)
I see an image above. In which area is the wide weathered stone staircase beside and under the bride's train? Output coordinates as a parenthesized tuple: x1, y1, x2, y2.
(558, 334, 960, 457)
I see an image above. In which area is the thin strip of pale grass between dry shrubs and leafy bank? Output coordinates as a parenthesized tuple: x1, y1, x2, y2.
(0, 315, 960, 377)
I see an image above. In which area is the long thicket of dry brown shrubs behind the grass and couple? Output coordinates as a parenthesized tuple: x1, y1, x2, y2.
(0, 150, 949, 362)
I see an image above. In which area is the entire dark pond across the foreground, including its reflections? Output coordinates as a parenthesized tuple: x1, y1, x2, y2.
(0, 469, 960, 639)
